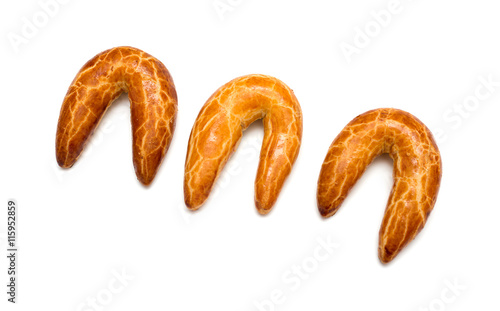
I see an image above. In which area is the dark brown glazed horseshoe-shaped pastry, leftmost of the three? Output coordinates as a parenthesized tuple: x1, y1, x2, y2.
(56, 47, 177, 185)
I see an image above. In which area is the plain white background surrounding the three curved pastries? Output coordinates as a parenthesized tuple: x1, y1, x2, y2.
(0, 0, 500, 311)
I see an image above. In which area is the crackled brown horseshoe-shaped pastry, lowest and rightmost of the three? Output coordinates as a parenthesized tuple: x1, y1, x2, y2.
(317, 109, 441, 263)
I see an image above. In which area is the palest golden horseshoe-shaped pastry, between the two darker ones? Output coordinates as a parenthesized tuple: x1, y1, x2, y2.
(184, 75, 302, 215)
